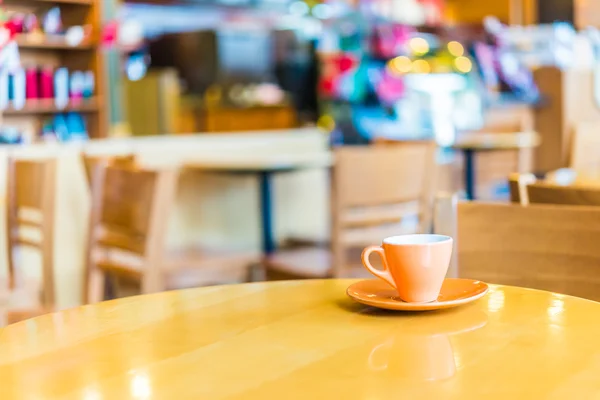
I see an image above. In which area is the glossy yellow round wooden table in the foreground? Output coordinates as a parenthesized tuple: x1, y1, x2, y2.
(0, 280, 600, 400)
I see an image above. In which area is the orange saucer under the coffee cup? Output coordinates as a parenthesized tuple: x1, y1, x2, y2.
(346, 278, 488, 311)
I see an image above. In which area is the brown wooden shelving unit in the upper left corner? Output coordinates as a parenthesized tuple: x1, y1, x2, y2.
(0, 0, 108, 138)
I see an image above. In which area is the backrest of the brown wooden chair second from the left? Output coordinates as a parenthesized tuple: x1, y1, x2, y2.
(84, 163, 175, 302)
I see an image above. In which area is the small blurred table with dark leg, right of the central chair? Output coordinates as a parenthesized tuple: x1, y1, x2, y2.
(452, 132, 540, 200)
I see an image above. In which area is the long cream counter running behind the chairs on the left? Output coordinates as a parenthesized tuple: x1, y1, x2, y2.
(0, 129, 329, 308)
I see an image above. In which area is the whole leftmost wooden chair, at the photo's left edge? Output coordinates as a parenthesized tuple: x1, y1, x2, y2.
(2, 158, 56, 323)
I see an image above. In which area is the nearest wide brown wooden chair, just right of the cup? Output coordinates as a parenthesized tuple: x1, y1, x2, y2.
(435, 195, 600, 300)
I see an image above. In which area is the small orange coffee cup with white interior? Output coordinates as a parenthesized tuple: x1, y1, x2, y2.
(362, 234, 452, 303)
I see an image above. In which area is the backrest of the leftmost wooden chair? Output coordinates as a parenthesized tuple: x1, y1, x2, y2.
(6, 158, 56, 308)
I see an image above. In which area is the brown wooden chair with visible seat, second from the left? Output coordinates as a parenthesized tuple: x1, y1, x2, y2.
(84, 164, 260, 303)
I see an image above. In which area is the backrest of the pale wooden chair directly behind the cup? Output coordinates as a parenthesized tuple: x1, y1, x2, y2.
(332, 141, 435, 276)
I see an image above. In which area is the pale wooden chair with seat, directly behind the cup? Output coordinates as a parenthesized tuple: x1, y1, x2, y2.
(265, 142, 435, 279)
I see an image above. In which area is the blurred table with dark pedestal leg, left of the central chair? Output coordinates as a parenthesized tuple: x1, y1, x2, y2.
(184, 152, 333, 254)
